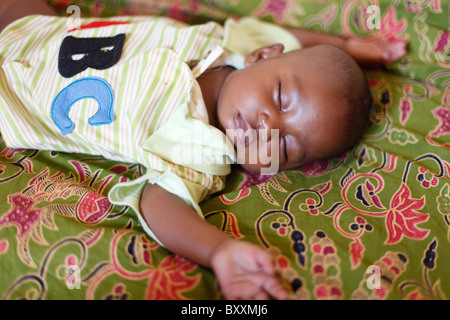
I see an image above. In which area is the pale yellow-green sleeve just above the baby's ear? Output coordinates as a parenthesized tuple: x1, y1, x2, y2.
(222, 17, 302, 69)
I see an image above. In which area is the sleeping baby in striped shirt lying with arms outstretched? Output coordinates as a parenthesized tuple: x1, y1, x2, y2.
(0, 0, 404, 299)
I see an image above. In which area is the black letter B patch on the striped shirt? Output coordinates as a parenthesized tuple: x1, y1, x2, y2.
(58, 33, 125, 78)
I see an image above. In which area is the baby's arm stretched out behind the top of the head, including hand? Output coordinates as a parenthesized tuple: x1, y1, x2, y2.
(288, 29, 406, 65)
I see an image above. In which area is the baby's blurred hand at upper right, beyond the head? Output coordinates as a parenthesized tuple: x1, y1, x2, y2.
(344, 38, 407, 64)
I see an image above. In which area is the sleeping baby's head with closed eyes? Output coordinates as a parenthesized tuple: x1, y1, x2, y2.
(217, 44, 372, 173)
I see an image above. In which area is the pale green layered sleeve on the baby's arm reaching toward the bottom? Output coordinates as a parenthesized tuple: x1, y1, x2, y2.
(108, 99, 235, 246)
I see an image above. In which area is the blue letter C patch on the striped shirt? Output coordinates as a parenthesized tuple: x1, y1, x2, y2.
(51, 77, 114, 135)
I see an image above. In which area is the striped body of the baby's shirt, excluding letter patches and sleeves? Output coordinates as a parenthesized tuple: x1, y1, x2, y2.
(0, 16, 229, 195)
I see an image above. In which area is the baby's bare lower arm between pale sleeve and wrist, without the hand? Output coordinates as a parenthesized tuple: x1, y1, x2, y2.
(140, 184, 232, 267)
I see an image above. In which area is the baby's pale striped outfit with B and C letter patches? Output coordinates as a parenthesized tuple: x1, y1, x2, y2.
(0, 16, 302, 241)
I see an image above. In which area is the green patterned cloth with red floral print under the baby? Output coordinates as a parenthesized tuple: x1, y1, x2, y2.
(0, 0, 450, 299)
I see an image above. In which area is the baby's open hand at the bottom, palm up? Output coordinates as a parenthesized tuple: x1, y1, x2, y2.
(211, 239, 287, 300)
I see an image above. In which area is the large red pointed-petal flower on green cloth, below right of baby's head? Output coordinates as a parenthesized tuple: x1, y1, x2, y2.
(386, 184, 430, 244)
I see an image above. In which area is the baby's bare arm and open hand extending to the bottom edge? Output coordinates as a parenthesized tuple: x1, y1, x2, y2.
(140, 184, 287, 299)
